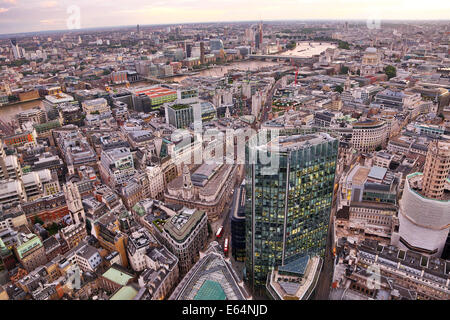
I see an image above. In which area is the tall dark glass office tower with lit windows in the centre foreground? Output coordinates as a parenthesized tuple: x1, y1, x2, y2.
(245, 133, 339, 292)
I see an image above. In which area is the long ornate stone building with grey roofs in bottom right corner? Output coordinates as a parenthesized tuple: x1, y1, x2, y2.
(335, 239, 450, 300)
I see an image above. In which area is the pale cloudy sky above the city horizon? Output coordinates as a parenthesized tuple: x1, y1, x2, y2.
(0, 0, 450, 34)
